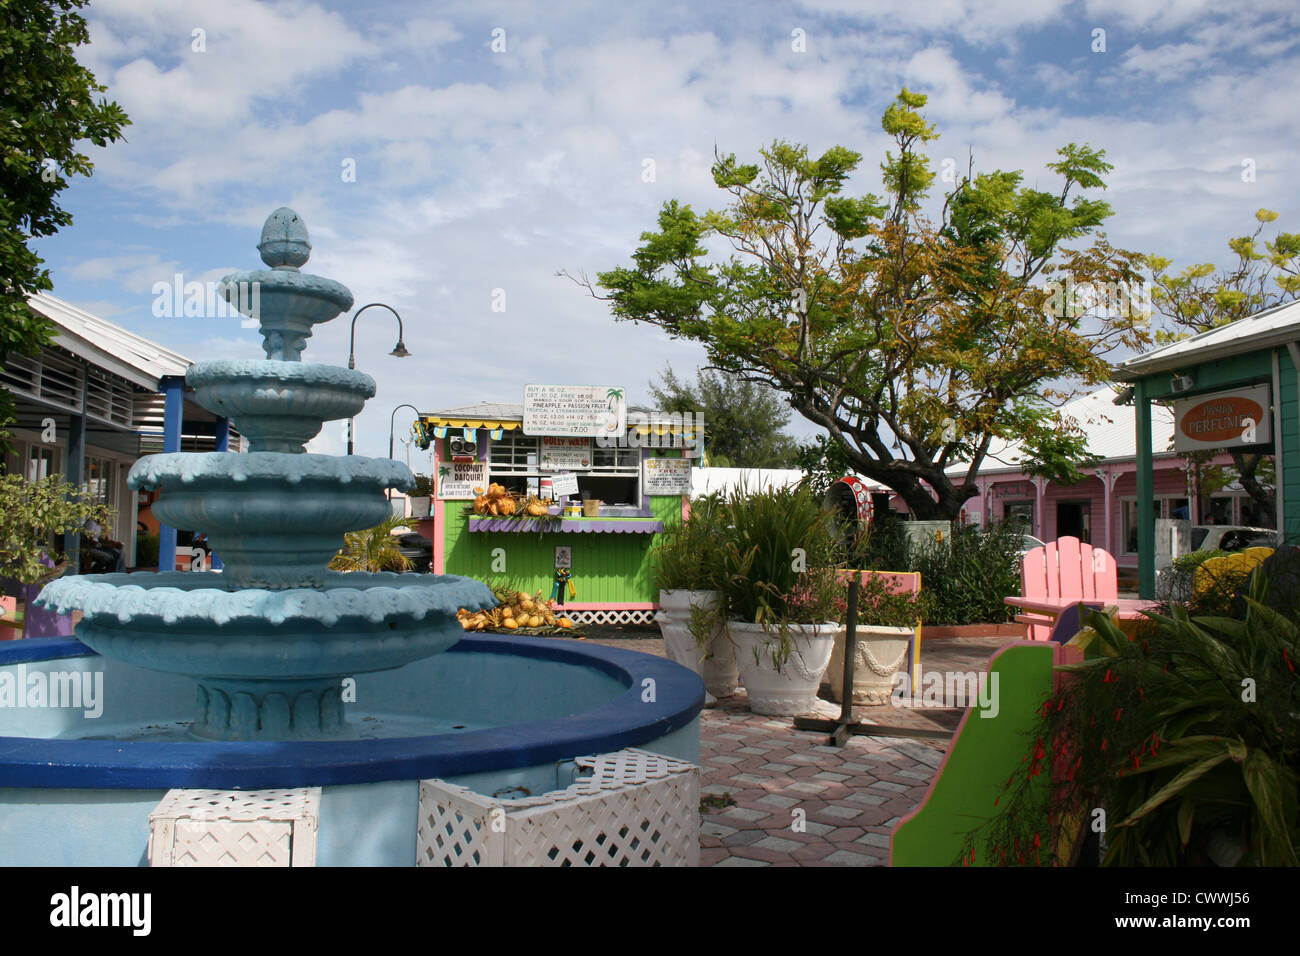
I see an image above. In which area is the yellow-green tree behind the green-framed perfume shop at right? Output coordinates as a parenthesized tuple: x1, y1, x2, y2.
(1147, 209, 1300, 514)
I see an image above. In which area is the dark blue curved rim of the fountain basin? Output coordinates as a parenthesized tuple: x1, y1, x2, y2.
(0, 635, 705, 790)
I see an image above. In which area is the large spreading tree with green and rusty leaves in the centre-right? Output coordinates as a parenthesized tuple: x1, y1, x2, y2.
(576, 90, 1148, 519)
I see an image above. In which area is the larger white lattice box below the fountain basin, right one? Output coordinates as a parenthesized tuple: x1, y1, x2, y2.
(416, 749, 699, 866)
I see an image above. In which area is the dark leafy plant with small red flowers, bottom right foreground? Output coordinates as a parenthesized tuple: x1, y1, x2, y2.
(959, 568, 1300, 866)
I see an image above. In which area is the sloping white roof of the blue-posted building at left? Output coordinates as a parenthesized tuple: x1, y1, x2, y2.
(27, 293, 194, 392)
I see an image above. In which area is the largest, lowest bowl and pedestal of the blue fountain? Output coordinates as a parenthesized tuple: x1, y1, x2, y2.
(40, 572, 495, 740)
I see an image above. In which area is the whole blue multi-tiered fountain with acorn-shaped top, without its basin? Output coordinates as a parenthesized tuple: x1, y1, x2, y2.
(42, 208, 494, 740)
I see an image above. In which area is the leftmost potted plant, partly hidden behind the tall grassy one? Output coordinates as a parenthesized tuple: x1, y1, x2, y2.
(651, 496, 740, 704)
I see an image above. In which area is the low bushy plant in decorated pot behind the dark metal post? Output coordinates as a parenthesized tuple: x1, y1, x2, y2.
(826, 572, 926, 705)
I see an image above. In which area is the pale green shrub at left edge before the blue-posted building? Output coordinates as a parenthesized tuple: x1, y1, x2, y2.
(0, 473, 113, 584)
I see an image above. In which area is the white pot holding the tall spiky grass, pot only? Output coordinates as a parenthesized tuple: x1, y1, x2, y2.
(727, 620, 840, 717)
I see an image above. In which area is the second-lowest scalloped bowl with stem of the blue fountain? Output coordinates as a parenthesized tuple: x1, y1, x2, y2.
(127, 451, 415, 588)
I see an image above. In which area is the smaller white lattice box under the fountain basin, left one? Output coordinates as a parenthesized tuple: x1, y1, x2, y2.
(150, 787, 321, 866)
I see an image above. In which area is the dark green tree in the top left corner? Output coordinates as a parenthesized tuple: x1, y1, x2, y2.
(0, 0, 130, 442)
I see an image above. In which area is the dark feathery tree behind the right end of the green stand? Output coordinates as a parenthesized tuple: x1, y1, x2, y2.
(650, 367, 794, 468)
